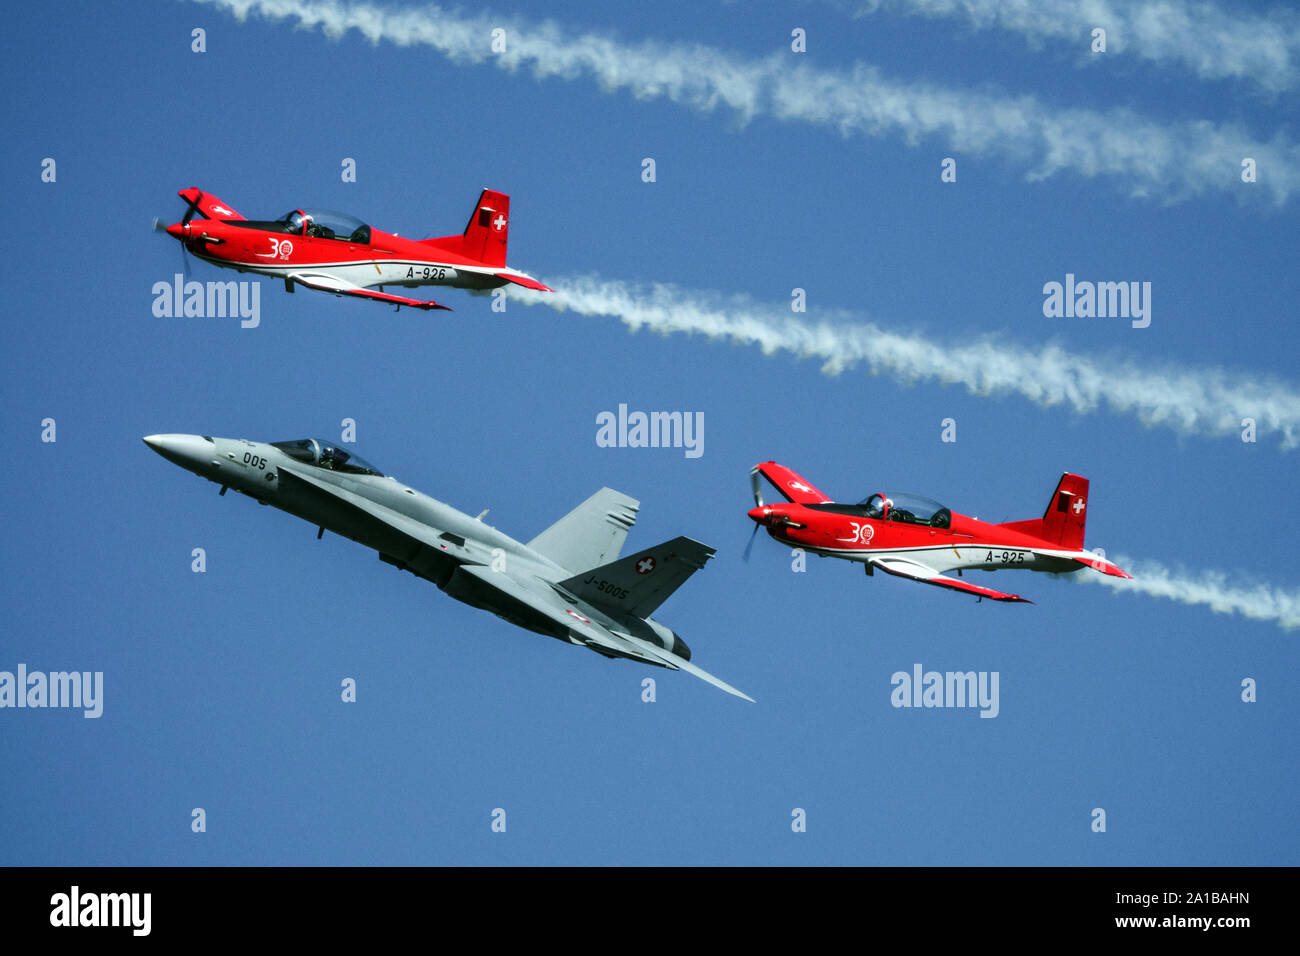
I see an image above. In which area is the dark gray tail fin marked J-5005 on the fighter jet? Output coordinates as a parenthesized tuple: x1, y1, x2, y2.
(559, 537, 714, 618)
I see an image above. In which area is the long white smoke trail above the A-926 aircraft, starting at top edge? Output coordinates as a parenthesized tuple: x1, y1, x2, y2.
(199, 0, 1300, 206)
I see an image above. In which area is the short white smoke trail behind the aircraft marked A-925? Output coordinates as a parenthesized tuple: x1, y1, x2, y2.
(1074, 555, 1300, 631)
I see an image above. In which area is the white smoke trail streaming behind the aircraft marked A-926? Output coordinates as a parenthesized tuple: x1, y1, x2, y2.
(510, 276, 1300, 449)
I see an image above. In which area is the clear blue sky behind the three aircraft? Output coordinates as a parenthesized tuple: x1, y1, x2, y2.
(0, 0, 1300, 865)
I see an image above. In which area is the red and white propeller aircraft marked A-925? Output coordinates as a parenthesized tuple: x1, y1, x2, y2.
(749, 462, 1132, 604)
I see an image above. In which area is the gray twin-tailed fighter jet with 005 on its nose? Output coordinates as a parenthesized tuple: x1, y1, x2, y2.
(144, 434, 753, 701)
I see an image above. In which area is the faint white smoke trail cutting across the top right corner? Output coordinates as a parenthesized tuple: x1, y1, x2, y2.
(835, 0, 1300, 94)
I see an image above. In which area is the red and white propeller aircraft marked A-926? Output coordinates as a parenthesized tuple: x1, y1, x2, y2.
(155, 187, 554, 311)
